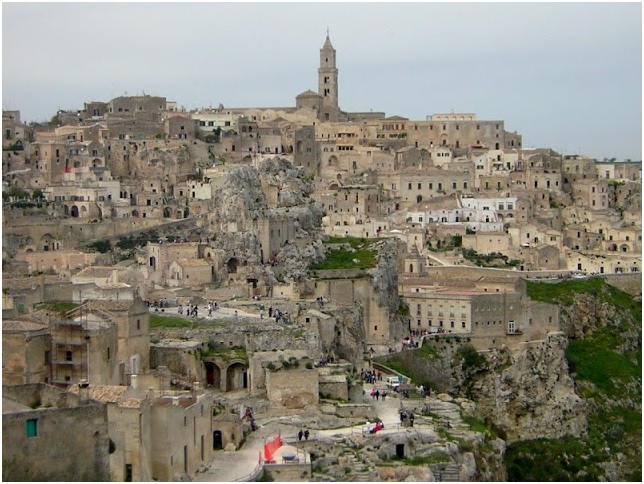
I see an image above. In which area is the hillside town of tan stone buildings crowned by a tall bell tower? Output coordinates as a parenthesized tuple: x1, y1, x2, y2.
(2, 34, 642, 481)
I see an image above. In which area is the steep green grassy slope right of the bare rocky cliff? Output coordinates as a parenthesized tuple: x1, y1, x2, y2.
(505, 277, 642, 482)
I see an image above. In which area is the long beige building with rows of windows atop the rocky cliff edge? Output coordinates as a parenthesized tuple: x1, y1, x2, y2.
(399, 264, 559, 349)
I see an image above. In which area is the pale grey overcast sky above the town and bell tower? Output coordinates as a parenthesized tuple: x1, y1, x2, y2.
(2, 2, 642, 160)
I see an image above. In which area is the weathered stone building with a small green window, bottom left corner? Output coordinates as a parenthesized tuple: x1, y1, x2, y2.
(2, 383, 110, 482)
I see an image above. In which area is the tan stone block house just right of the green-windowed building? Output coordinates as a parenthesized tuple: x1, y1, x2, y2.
(69, 377, 213, 482)
